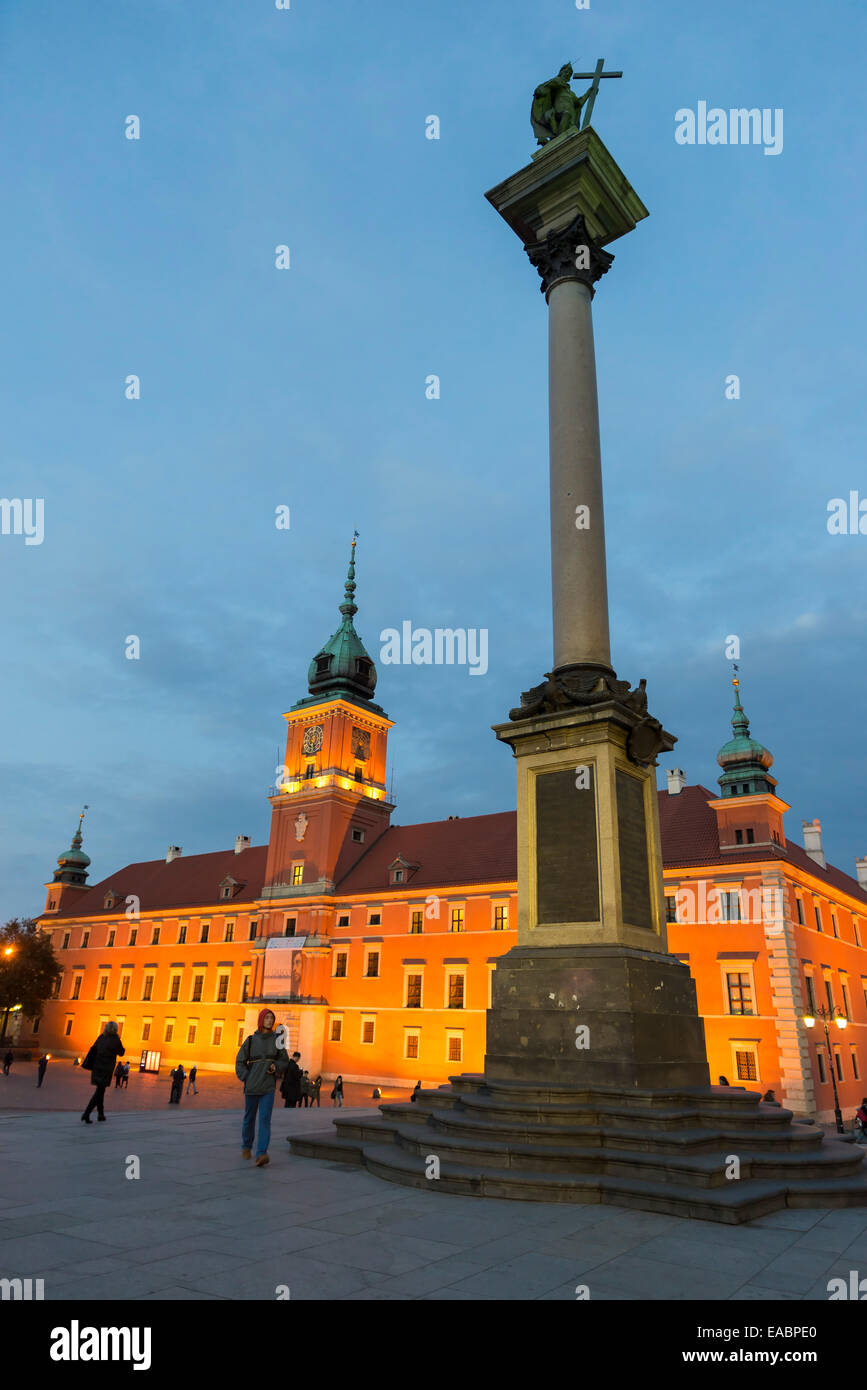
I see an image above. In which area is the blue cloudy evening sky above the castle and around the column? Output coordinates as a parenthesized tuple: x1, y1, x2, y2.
(0, 0, 867, 920)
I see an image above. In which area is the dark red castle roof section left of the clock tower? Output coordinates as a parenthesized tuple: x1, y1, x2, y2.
(46, 845, 268, 920)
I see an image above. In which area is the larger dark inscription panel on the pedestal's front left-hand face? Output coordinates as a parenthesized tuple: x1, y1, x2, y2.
(536, 767, 599, 923)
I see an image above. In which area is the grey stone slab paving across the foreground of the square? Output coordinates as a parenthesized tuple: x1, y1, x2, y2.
(0, 1106, 867, 1301)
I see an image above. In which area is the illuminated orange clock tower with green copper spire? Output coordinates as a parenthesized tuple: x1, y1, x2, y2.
(257, 538, 395, 899)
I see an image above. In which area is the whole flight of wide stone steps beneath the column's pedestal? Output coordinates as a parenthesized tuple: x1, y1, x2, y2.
(292, 1074, 867, 1225)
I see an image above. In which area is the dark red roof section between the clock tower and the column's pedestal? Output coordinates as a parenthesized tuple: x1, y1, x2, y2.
(338, 810, 518, 894)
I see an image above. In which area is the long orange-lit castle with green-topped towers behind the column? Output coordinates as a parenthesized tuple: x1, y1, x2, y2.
(30, 542, 867, 1119)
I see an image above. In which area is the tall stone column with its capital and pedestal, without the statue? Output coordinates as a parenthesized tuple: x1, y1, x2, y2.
(485, 126, 709, 1088)
